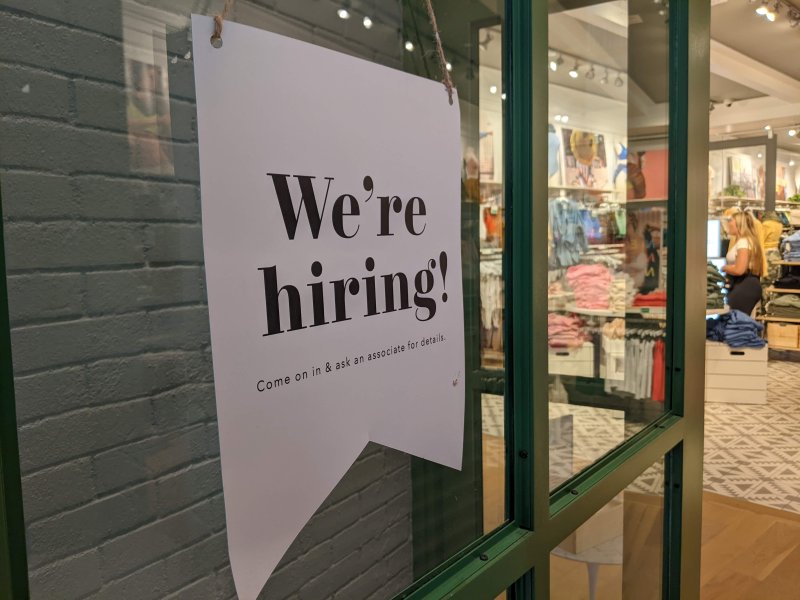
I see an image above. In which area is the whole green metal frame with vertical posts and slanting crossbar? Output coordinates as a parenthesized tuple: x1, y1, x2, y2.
(0, 0, 710, 600)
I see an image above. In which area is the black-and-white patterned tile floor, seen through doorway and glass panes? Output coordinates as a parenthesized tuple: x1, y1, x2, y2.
(483, 353, 800, 513)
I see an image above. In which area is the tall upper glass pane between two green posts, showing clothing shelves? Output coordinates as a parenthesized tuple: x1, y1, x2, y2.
(548, 0, 669, 486)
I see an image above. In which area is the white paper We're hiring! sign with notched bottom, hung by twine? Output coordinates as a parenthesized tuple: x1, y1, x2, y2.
(192, 16, 465, 600)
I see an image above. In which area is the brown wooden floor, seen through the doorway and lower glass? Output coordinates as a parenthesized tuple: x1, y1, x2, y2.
(484, 436, 800, 600)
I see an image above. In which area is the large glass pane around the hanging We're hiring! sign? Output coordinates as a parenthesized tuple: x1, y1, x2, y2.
(0, 0, 507, 600)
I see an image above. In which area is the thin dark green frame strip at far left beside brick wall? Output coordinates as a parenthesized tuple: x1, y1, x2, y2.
(0, 184, 28, 600)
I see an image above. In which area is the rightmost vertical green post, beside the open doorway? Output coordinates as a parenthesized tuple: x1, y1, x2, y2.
(665, 1, 711, 600)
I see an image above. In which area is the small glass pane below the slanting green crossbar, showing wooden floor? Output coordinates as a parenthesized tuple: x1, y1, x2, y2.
(550, 460, 664, 600)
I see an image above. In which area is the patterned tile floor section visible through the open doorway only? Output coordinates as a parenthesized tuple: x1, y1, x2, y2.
(704, 360, 800, 513)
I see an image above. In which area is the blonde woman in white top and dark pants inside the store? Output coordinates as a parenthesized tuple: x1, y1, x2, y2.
(722, 212, 764, 315)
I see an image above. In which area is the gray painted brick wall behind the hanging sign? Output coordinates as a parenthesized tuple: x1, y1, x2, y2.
(0, 0, 412, 600)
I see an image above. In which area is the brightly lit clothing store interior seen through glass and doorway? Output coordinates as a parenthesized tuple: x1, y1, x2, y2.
(472, 0, 800, 598)
